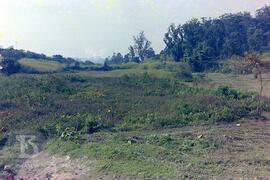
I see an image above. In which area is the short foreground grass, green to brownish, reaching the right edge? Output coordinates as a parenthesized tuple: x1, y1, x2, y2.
(46, 121, 270, 179)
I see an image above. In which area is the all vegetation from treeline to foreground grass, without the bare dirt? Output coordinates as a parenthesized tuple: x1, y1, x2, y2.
(0, 4, 270, 179)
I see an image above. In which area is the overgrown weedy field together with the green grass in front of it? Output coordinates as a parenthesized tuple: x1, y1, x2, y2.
(0, 63, 270, 179)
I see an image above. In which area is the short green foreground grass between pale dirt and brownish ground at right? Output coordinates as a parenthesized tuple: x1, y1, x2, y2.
(48, 129, 219, 179)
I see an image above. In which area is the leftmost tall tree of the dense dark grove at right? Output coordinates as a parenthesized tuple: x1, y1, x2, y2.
(163, 24, 184, 61)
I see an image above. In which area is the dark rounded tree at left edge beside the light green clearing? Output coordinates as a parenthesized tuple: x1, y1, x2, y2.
(0, 58, 21, 75)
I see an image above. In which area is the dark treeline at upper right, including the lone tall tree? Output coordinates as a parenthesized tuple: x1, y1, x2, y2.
(106, 6, 270, 71)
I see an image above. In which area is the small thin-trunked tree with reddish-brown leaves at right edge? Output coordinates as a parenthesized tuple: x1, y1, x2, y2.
(244, 53, 270, 118)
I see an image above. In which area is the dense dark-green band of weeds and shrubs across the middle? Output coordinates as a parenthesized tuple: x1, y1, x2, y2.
(0, 75, 265, 141)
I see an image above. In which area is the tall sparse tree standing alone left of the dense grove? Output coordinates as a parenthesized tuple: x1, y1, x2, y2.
(129, 31, 153, 62)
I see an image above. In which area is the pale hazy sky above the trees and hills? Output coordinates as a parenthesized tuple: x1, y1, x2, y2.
(0, 0, 270, 58)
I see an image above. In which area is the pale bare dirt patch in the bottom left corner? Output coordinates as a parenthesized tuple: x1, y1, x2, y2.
(17, 152, 94, 180)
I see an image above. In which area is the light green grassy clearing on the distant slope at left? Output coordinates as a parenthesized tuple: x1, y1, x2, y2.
(19, 58, 65, 72)
